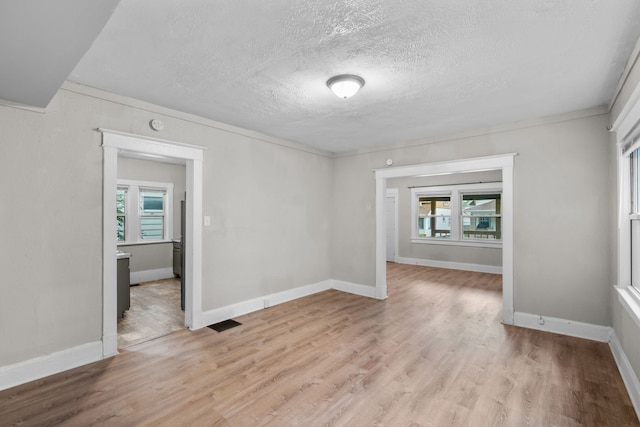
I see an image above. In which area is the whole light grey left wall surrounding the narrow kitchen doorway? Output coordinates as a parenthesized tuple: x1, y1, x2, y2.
(0, 83, 332, 367)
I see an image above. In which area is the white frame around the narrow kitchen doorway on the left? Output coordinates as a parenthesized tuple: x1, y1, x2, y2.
(98, 129, 204, 357)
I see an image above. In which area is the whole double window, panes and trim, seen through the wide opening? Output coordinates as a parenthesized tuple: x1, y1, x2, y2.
(411, 183, 502, 246)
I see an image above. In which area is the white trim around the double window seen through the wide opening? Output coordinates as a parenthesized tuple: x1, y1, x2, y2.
(410, 182, 503, 248)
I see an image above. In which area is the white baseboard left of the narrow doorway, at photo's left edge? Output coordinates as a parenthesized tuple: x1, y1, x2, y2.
(0, 341, 103, 390)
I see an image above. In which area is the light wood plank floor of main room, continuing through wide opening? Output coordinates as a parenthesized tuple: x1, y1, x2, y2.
(0, 264, 640, 427)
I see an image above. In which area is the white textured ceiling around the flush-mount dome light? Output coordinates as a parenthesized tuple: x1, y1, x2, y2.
(69, 0, 640, 152)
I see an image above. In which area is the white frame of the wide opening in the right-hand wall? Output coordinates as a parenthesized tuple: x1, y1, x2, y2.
(374, 153, 517, 325)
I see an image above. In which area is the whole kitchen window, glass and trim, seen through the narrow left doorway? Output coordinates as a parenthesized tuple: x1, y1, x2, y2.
(116, 180, 173, 244)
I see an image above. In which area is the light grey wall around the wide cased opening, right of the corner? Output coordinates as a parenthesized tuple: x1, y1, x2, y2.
(332, 110, 611, 325)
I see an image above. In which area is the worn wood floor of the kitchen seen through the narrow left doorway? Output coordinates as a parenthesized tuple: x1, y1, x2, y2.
(118, 279, 185, 348)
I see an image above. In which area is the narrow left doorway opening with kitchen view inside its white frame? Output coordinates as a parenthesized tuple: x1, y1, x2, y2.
(117, 159, 186, 349)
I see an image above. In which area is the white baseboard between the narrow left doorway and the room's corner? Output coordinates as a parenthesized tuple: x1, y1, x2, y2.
(202, 280, 331, 326)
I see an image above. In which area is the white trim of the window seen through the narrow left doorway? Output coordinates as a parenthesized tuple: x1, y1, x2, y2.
(117, 179, 173, 246)
